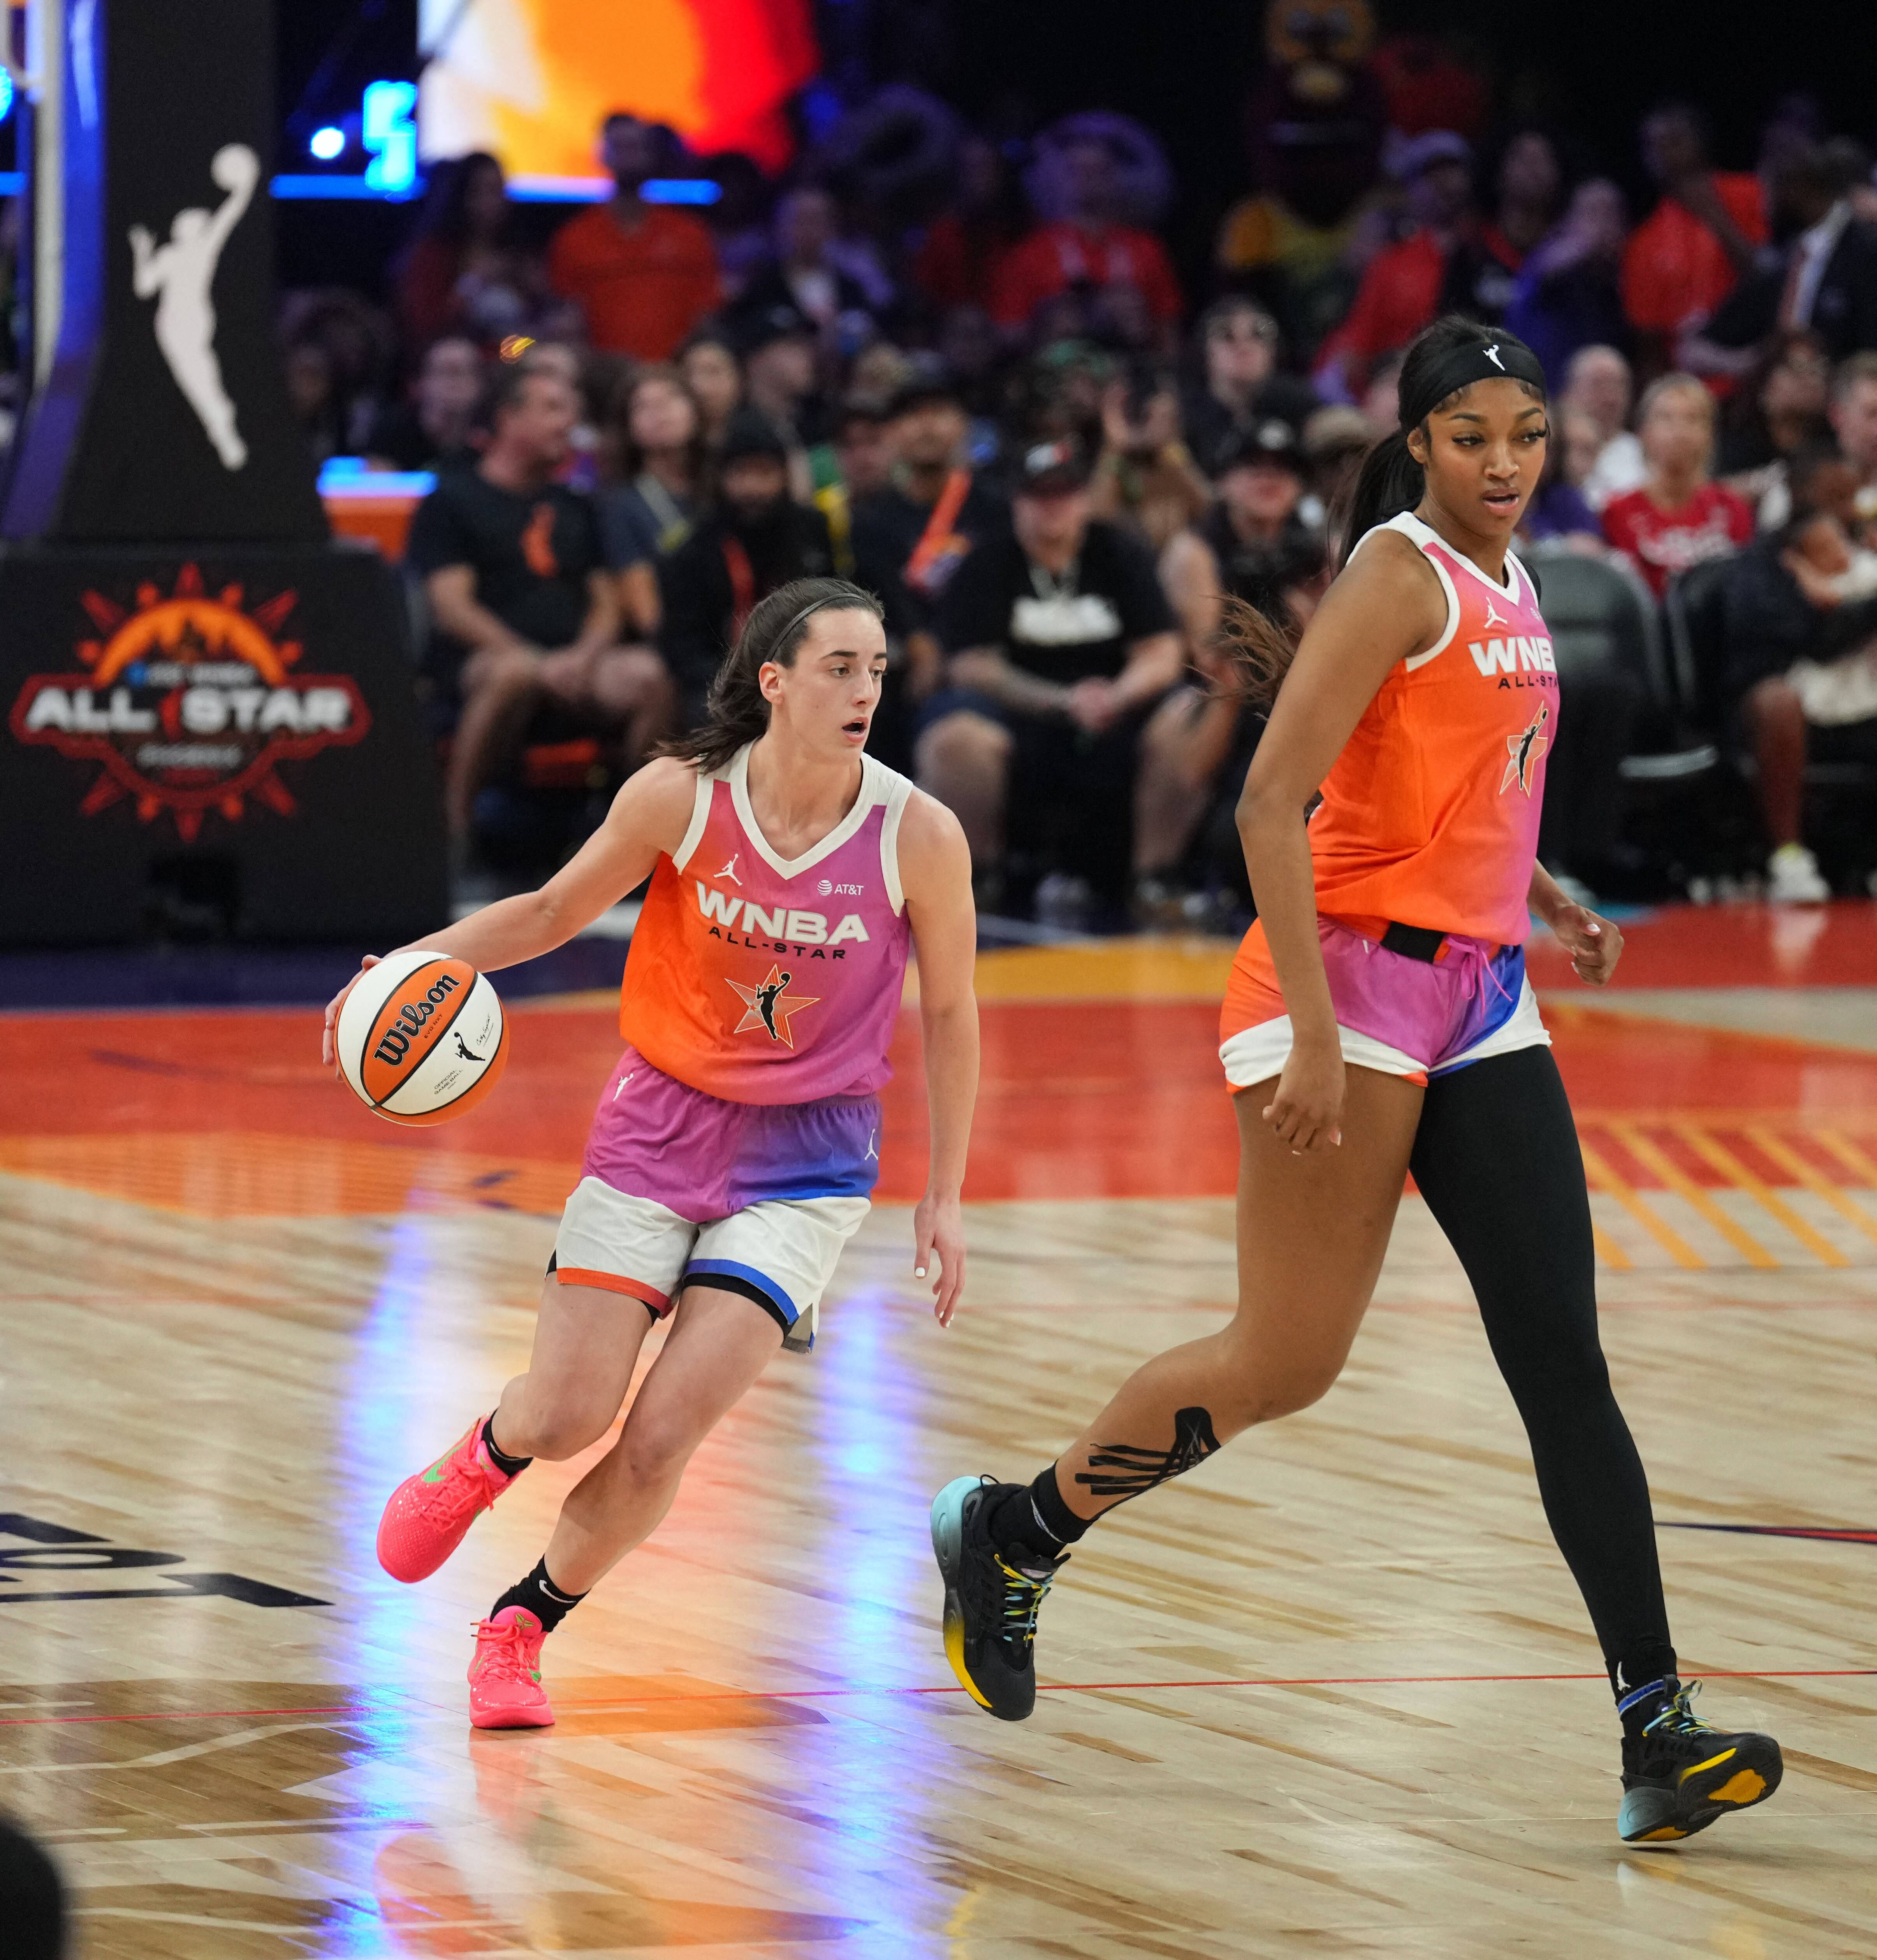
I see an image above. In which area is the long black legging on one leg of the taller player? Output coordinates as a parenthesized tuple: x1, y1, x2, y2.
(1410, 1049, 1675, 1688)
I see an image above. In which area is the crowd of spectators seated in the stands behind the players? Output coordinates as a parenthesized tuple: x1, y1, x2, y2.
(284, 90, 1877, 923)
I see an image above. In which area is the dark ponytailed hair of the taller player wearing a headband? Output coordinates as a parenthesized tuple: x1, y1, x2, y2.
(1220, 314, 1544, 708)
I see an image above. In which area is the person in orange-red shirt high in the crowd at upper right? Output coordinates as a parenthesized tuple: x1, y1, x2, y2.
(1622, 102, 1767, 369)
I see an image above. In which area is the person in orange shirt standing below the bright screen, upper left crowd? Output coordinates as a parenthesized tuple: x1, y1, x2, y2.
(547, 114, 724, 360)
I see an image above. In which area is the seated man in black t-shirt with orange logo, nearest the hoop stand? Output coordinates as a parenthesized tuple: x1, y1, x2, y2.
(408, 367, 671, 839)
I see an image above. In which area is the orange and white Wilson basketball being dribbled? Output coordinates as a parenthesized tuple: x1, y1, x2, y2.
(335, 949, 508, 1123)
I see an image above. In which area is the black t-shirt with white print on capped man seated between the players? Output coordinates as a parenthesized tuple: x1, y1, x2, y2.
(939, 523, 1173, 684)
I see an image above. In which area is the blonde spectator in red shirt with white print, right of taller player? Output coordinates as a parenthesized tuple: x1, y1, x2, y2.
(1603, 374, 1754, 598)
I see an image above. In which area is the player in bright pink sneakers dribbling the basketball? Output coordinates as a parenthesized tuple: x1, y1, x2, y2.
(325, 578, 979, 1729)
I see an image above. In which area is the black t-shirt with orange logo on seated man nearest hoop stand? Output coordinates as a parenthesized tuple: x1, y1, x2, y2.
(406, 470, 606, 647)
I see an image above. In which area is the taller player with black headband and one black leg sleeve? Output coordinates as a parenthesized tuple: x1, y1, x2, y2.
(932, 320, 1781, 1842)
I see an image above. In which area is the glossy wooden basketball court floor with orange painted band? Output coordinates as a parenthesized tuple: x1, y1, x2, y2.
(0, 909, 1877, 1960)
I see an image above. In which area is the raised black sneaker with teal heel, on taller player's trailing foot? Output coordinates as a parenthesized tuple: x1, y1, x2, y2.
(932, 1476, 1069, 1721)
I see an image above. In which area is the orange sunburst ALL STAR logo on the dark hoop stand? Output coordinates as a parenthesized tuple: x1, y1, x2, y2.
(8, 564, 371, 841)
